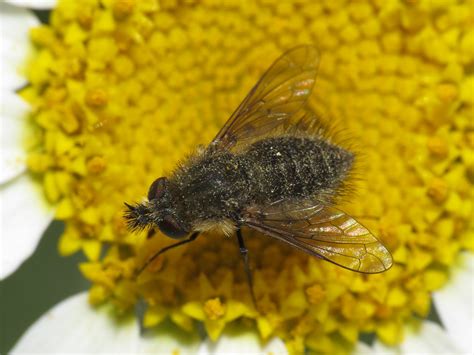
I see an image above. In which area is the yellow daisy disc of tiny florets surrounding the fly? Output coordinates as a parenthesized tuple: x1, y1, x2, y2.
(20, 0, 474, 353)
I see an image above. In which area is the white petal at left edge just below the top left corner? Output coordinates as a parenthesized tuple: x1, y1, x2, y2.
(0, 1, 39, 91)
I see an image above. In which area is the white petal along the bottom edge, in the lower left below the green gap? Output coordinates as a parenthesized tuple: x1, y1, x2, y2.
(12, 293, 199, 354)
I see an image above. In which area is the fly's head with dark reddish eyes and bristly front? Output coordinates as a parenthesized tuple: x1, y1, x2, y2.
(125, 177, 190, 239)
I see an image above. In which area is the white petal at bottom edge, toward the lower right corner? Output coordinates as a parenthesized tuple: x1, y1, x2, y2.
(354, 321, 463, 355)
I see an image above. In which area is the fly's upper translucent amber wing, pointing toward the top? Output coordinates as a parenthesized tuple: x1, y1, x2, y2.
(211, 45, 319, 150)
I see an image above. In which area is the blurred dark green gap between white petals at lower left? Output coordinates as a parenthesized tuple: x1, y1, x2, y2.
(0, 221, 89, 354)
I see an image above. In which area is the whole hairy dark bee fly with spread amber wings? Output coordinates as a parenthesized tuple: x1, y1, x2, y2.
(125, 46, 392, 302)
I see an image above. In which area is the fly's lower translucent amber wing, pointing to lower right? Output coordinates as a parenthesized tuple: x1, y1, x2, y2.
(244, 202, 392, 274)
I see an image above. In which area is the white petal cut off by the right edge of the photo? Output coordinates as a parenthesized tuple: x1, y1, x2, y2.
(433, 252, 474, 354)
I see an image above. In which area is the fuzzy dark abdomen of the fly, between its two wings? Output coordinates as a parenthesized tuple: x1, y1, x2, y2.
(241, 136, 354, 203)
